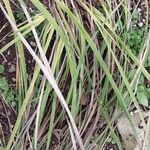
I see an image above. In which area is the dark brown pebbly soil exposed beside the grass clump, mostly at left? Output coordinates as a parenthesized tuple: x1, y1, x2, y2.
(0, 0, 148, 150)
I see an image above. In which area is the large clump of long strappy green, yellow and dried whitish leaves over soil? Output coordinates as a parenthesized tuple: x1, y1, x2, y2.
(0, 0, 150, 150)
